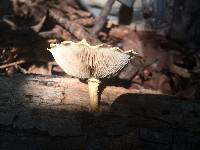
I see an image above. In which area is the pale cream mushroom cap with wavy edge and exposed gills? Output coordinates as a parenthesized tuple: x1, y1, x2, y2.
(49, 40, 131, 79)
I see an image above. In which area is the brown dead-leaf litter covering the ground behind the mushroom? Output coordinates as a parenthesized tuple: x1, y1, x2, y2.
(0, 0, 200, 99)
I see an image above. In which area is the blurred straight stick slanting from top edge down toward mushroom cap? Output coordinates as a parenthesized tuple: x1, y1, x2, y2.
(91, 0, 115, 36)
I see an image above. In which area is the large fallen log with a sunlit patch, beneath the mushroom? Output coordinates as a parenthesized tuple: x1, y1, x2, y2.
(0, 75, 200, 150)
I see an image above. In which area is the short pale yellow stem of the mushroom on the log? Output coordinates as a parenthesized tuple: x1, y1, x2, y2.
(88, 78, 100, 112)
